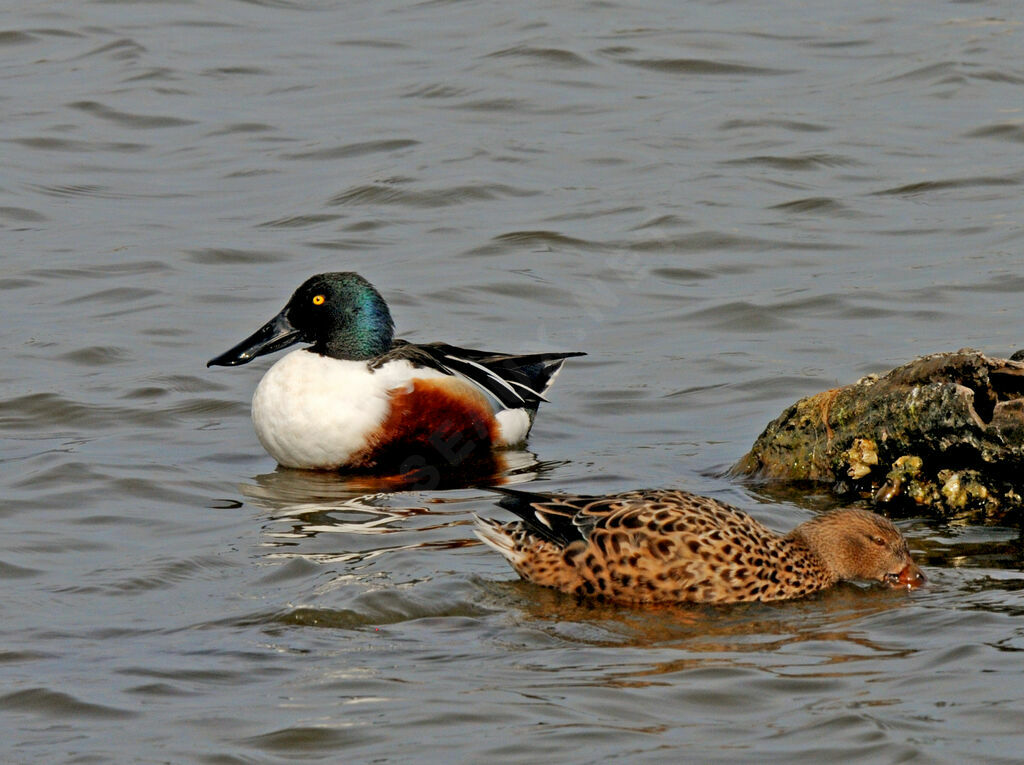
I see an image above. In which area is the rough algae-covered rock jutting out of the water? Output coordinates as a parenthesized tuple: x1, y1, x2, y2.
(733, 348, 1024, 520)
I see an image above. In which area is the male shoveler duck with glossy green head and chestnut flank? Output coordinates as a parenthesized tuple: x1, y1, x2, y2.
(207, 272, 584, 473)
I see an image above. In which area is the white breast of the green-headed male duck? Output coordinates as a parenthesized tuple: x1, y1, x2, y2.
(253, 350, 443, 470)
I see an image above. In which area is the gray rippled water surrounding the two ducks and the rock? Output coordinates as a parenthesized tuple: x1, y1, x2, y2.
(6, 0, 1024, 763)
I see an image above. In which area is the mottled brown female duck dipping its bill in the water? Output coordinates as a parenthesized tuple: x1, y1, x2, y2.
(476, 488, 925, 604)
